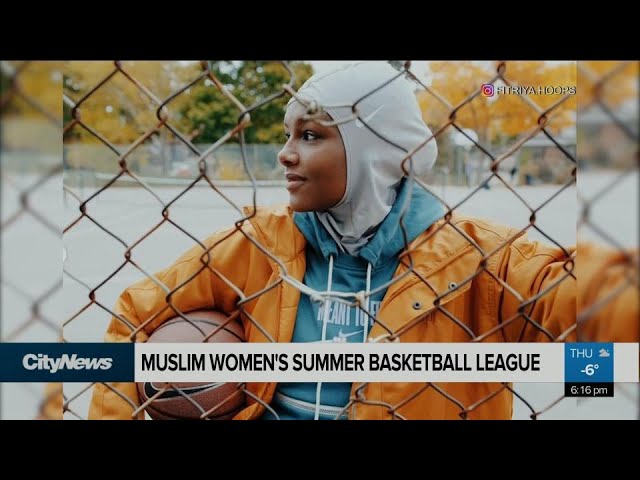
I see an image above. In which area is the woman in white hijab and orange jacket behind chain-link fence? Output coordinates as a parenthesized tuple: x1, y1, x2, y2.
(90, 62, 636, 419)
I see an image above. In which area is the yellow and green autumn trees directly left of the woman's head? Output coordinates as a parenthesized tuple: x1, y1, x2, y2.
(59, 61, 312, 145)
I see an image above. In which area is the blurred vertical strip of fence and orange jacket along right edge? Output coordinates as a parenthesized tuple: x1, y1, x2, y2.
(576, 61, 640, 419)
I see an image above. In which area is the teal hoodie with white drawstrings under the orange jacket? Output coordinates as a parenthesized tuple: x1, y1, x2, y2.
(263, 179, 444, 420)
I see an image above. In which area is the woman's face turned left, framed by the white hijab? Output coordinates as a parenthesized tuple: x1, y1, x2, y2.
(278, 102, 347, 212)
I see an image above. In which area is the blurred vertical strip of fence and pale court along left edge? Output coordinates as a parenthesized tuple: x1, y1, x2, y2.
(0, 61, 63, 419)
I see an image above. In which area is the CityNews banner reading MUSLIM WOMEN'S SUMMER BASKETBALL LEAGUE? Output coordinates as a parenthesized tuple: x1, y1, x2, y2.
(0, 343, 639, 397)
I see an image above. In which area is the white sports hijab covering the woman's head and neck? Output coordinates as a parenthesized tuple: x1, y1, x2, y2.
(289, 62, 438, 255)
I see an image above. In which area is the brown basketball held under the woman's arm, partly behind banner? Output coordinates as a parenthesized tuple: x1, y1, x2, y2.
(137, 310, 246, 420)
